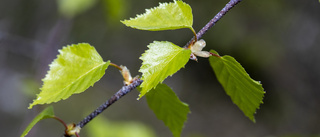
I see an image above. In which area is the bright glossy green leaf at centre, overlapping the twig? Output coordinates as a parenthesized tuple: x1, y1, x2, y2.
(139, 41, 191, 98)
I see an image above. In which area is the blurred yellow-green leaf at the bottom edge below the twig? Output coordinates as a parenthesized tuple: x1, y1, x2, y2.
(86, 117, 155, 137)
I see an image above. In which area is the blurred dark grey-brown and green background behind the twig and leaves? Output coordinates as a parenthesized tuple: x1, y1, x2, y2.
(0, 0, 320, 137)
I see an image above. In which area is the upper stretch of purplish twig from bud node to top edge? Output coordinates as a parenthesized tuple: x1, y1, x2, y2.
(184, 0, 242, 48)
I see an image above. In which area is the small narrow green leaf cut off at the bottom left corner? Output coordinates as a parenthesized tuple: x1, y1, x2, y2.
(20, 106, 54, 137)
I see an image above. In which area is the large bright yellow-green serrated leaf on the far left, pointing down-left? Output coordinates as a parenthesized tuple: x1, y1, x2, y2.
(29, 43, 110, 109)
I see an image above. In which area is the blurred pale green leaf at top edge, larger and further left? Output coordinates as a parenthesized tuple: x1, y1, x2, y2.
(57, 0, 97, 18)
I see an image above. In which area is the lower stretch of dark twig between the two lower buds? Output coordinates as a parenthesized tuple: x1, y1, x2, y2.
(77, 79, 142, 128)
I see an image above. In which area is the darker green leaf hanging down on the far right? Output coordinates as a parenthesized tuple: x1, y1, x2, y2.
(209, 50, 265, 122)
